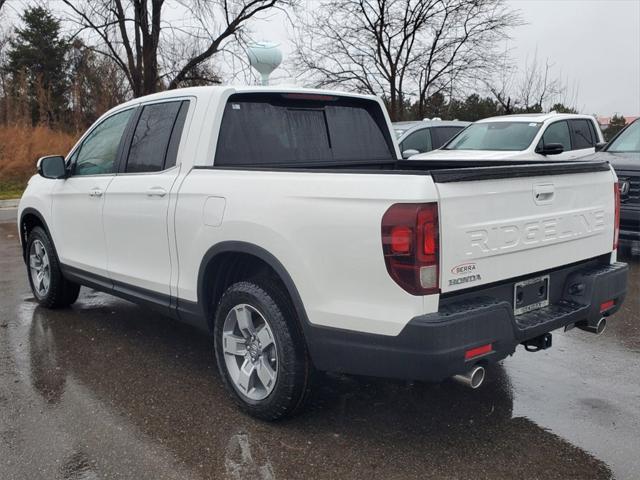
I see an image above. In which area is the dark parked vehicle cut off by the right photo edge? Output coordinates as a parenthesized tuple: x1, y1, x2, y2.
(585, 119, 640, 252)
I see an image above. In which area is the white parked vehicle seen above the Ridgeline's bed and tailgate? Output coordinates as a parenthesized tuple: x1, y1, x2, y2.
(411, 112, 604, 161)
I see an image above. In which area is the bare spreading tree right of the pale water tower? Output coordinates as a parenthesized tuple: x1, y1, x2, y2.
(294, 0, 519, 120)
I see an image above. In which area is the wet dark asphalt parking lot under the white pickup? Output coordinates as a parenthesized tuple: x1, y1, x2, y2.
(0, 210, 640, 480)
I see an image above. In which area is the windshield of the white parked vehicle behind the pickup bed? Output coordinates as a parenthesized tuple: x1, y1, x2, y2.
(444, 122, 542, 151)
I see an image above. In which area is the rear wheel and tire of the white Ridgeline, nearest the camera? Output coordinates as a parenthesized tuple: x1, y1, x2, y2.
(214, 280, 311, 420)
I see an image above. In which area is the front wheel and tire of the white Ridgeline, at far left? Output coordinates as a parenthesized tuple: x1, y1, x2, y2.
(26, 227, 80, 308)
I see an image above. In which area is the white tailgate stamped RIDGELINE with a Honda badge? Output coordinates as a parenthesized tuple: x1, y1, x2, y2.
(432, 162, 615, 293)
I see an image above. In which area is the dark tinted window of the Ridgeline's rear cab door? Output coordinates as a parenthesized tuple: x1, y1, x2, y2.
(125, 101, 189, 173)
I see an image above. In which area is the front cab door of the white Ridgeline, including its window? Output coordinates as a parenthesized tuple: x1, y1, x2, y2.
(51, 108, 135, 279)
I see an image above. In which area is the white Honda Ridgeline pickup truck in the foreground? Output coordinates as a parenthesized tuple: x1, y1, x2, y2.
(18, 87, 627, 420)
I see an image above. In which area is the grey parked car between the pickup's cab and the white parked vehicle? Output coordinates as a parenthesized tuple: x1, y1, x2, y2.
(393, 119, 470, 158)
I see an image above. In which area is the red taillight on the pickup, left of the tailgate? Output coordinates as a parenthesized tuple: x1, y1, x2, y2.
(382, 203, 440, 295)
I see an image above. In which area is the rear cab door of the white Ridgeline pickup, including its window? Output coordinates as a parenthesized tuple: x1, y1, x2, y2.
(104, 99, 190, 296)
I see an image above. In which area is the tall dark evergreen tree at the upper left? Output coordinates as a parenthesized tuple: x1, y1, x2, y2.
(6, 7, 69, 125)
